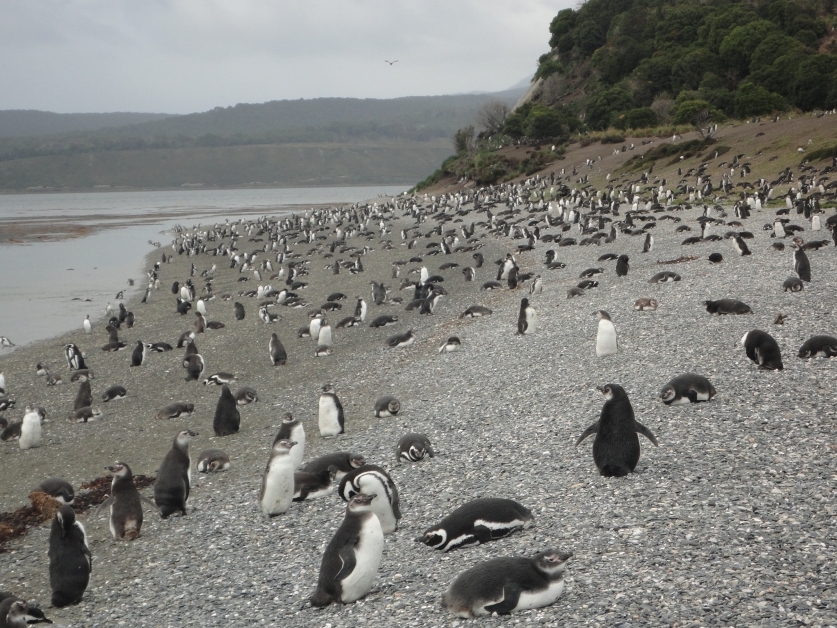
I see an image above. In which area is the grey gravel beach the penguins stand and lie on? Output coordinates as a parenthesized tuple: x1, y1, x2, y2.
(0, 188, 837, 628)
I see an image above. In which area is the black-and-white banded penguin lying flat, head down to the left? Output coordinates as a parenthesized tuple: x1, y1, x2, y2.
(416, 497, 534, 552)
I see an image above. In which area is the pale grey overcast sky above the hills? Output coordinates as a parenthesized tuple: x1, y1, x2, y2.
(0, 0, 576, 113)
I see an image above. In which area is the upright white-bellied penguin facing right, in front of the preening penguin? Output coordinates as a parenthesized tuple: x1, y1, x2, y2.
(311, 493, 384, 607)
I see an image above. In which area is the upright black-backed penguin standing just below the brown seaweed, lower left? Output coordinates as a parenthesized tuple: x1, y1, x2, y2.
(48, 504, 93, 608)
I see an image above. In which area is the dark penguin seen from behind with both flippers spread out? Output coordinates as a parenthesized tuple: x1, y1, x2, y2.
(575, 384, 659, 477)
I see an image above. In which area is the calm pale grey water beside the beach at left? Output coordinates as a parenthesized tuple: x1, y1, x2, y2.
(0, 186, 406, 353)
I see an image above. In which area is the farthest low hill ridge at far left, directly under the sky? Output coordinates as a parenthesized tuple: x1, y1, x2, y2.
(0, 109, 170, 137)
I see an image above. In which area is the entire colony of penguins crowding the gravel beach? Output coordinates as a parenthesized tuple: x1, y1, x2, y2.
(0, 145, 837, 625)
